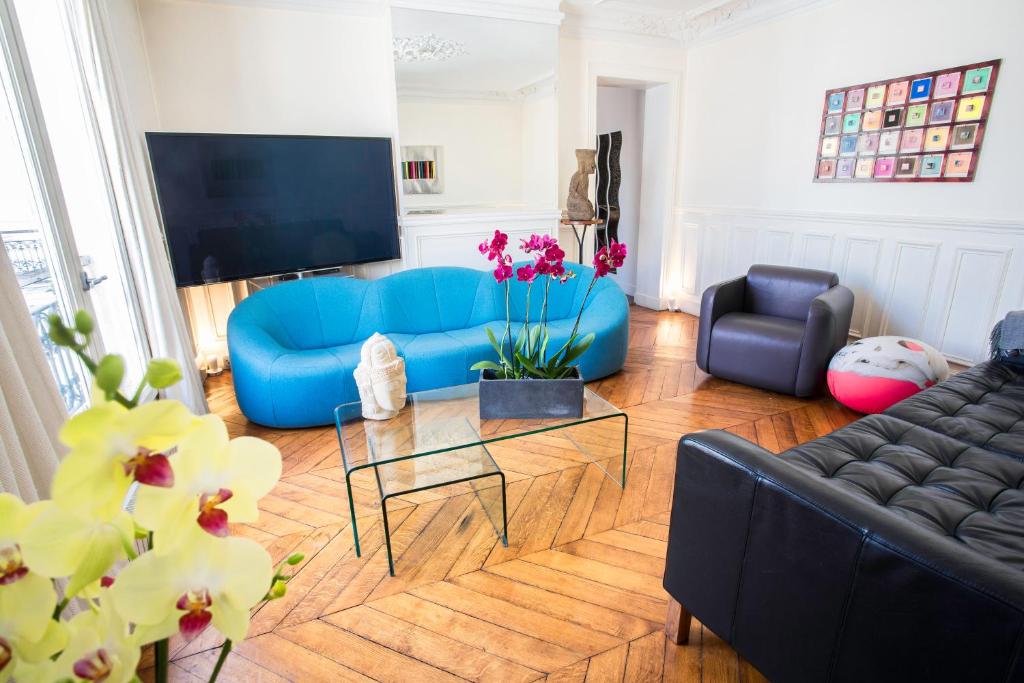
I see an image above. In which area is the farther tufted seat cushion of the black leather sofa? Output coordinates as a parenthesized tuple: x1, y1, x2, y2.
(886, 362, 1024, 458)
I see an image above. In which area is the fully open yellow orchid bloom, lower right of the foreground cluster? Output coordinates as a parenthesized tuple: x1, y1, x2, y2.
(110, 526, 273, 643)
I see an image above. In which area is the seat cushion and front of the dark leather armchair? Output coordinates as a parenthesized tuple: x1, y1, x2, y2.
(709, 313, 804, 393)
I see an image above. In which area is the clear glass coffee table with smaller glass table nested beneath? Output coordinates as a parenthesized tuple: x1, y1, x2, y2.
(334, 384, 629, 577)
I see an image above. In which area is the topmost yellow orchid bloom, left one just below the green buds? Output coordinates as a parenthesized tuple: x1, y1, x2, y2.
(52, 400, 197, 512)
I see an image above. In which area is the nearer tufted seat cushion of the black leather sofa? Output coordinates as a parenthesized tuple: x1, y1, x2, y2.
(779, 415, 1024, 569)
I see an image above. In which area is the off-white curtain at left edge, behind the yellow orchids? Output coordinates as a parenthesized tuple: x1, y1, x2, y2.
(0, 242, 68, 503)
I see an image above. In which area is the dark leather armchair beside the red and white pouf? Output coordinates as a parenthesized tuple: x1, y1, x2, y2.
(696, 265, 853, 396)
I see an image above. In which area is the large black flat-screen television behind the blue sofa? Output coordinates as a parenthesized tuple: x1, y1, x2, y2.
(145, 133, 400, 287)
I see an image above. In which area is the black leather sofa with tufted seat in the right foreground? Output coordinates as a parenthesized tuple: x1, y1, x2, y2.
(665, 362, 1024, 682)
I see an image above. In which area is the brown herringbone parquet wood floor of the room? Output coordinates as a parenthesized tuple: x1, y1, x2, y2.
(155, 307, 857, 683)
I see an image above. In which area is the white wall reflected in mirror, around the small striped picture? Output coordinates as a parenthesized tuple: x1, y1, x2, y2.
(398, 97, 523, 209)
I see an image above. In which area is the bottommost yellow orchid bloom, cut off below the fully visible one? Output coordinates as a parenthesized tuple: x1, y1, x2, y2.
(37, 601, 141, 683)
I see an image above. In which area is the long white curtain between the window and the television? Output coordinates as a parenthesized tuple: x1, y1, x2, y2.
(66, 0, 208, 414)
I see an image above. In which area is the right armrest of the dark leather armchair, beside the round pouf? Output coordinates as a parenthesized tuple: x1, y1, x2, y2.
(794, 285, 853, 396)
